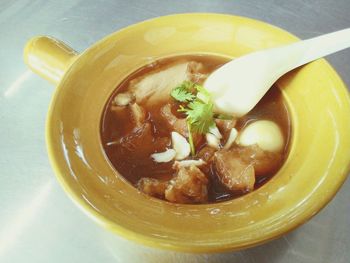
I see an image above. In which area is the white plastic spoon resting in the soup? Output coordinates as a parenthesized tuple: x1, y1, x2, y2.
(204, 28, 350, 117)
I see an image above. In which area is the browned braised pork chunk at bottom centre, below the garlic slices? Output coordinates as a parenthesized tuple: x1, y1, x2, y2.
(165, 165, 209, 204)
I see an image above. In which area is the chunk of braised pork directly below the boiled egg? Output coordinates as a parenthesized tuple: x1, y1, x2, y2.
(214, 150, 255, 192)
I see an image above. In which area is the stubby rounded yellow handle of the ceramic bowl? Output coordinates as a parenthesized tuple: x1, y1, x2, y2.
(24, 36, 78, 84)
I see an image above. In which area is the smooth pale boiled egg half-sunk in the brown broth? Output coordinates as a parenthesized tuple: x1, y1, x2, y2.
(237, 120, 284, 152)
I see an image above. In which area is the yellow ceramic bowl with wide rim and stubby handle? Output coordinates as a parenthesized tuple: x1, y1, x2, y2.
(25, 14, 350, 252)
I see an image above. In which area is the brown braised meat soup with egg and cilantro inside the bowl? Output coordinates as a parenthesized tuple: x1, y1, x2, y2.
(101, 55, 291, 204)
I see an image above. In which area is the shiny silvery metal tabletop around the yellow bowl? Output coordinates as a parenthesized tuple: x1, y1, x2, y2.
(0, 0, 350, 263)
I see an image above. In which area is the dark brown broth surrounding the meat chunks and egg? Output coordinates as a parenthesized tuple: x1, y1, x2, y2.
(101, 55, 291, 203)
